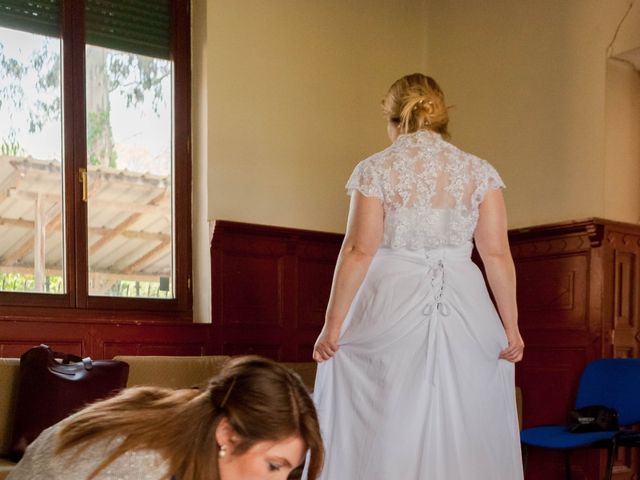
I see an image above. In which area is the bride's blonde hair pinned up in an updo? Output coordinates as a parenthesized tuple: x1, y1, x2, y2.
(382, 73, 450, 138)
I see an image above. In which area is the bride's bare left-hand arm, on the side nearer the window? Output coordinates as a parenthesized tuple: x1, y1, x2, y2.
(313, 191, 384, 362)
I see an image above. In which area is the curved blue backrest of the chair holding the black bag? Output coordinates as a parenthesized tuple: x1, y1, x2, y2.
(576, 358, 640, 425)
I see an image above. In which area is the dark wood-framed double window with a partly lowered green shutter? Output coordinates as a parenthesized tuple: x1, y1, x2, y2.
(0, 0, 191, 312)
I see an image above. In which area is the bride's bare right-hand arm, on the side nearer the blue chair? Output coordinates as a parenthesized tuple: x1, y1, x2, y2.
(474, 189, 524, 362)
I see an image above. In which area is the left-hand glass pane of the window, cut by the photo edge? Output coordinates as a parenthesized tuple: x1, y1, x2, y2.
(0, 27, 65, 293)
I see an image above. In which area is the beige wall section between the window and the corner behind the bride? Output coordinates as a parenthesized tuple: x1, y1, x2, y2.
(205, 0, 426, 232)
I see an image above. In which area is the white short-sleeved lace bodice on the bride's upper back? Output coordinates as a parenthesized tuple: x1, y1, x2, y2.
(346, 130, 504, 250)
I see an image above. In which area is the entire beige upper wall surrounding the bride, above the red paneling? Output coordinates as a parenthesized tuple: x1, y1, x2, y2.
(193, 0, 640, 319)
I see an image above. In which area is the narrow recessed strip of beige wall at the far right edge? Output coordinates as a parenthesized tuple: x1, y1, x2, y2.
(605, 60, 640, 223)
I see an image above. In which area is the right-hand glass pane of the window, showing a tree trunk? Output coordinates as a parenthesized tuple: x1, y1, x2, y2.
(86, 45, 174, 298)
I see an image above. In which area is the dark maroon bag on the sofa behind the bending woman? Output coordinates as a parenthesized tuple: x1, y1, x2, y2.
(9, 345, 129, 461)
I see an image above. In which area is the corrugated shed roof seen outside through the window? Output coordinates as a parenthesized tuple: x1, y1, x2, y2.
(0, 155, 172, 294)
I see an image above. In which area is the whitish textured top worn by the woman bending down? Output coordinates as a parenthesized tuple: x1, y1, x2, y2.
(7, 417, 171, 480)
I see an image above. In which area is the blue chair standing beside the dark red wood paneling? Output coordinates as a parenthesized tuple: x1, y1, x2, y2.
(520, 358, 640, 480)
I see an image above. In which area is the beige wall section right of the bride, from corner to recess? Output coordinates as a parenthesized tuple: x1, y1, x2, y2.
(427, 0, 640, 227)
